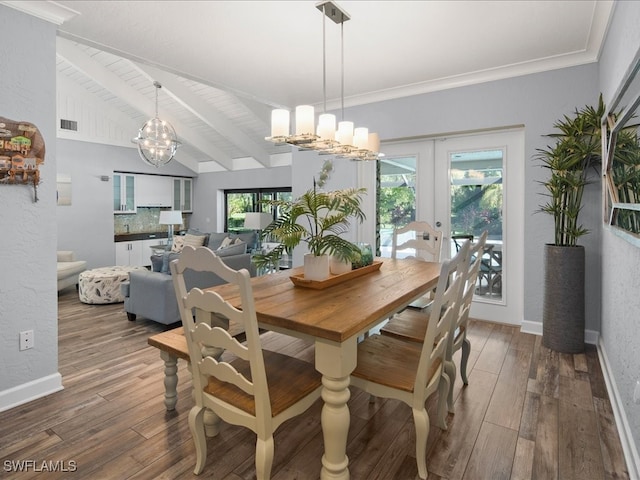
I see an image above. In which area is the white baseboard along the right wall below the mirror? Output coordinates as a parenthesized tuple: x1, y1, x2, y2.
(598, 341, 640, 480)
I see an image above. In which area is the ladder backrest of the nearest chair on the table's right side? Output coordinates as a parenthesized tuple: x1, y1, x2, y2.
(414, 242, 469, 393)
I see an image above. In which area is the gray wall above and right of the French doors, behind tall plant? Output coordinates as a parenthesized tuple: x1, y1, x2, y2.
(340, 64, 600, 331)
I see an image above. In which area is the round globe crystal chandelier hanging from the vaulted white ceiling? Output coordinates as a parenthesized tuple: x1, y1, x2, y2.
(131, 82, 180, 167)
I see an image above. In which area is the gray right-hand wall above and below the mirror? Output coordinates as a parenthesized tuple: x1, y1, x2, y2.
(600, 2, 640, 462)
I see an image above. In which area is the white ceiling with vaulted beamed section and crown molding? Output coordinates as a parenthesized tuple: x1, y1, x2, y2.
(0, 0, 615, 171)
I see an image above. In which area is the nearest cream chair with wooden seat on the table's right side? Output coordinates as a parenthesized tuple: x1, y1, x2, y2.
(351, 245, 468, 479)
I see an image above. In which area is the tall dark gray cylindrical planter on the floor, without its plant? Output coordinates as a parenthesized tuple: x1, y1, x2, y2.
(542, 245, 585, 353)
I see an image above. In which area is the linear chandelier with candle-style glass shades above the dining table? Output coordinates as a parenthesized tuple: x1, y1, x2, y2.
(265, 0, 383, 160)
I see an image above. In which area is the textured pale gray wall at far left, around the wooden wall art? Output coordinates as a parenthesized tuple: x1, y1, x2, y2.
(0, 5, 62, 410)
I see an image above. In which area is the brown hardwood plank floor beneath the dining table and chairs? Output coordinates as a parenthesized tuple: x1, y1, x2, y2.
(0, 289, 628, 480)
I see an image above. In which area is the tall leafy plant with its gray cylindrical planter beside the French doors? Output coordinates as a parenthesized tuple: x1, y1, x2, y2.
(536, 96, 605, 353)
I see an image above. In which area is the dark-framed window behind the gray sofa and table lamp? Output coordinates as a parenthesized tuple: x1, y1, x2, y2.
(224, 187, 291, 232)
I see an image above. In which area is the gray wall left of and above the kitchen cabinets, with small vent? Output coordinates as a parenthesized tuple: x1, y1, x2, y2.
(56, 139, 194, 268)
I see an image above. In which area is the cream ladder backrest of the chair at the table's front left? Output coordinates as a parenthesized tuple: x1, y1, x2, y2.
(171, 246, 271, 423)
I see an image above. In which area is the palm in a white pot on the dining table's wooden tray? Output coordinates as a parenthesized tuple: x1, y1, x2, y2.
(253, 180, 366, 280)
